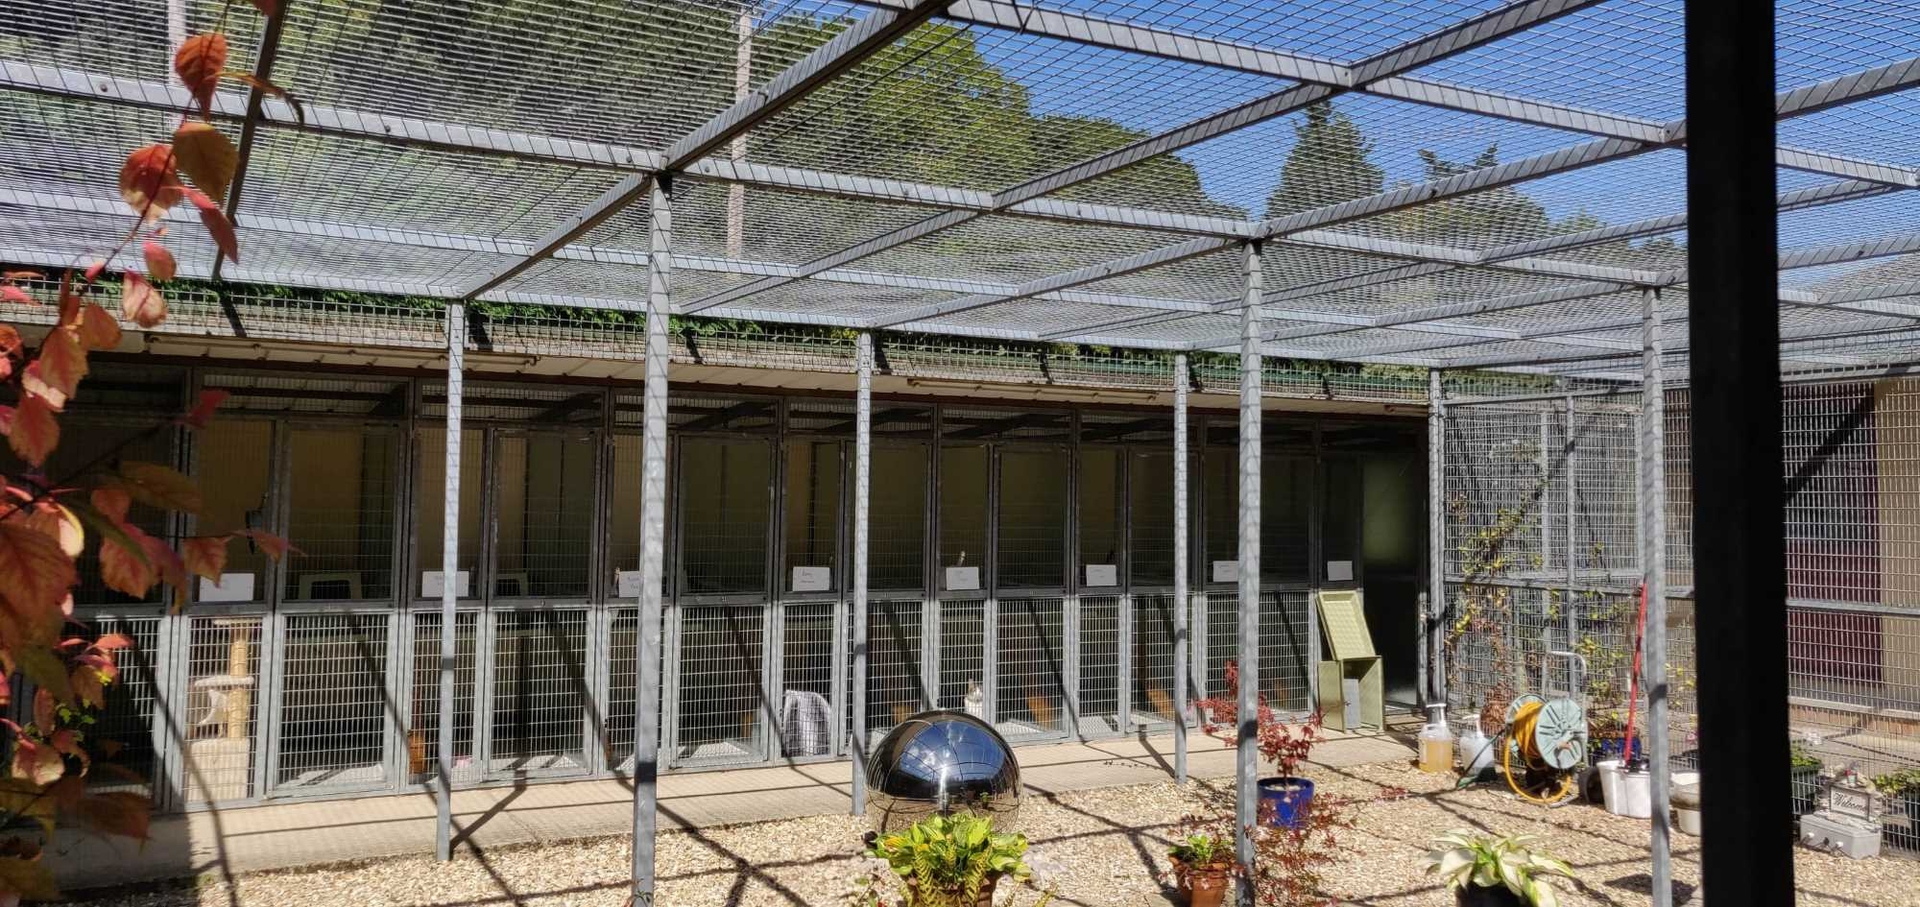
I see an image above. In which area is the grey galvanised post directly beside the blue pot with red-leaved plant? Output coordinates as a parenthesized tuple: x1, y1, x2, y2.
(1235, 242, 1261, 903)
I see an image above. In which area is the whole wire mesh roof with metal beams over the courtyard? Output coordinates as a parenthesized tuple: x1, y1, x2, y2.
(0, 0, 1920, 377)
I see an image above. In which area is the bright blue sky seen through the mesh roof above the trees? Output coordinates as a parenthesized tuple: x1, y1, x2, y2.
(960, 0, 1920, 219)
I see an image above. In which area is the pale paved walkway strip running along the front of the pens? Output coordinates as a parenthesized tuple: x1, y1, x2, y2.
(50, 734, 1413, 890)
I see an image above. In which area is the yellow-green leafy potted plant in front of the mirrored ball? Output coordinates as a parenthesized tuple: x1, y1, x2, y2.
(860, 813, 1054, 907)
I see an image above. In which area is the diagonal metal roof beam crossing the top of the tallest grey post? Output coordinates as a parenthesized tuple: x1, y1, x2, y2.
(461, 0, 943, 300)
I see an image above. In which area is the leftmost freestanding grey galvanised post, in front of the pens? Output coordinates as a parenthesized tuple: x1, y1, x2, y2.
(434, 302, 467, 861)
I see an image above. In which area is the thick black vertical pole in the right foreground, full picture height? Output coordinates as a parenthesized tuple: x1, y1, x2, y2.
(1689, 0, 1793, 907)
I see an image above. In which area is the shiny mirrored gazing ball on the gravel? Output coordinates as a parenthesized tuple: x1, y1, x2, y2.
(866, 709, 1020, 834)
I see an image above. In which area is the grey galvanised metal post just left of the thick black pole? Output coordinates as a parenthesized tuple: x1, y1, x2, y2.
(1640, 288, 1674, 907)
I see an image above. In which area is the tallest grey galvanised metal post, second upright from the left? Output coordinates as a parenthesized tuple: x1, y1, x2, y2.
(634, 173, 674, 905)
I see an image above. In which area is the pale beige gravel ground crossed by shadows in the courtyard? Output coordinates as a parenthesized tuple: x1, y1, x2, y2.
(67, 765, 1920, 907)
